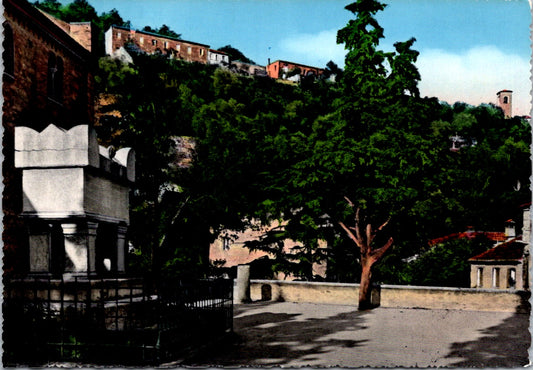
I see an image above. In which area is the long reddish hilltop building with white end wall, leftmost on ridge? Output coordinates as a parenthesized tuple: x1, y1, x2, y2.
(105, 26, 209, 64)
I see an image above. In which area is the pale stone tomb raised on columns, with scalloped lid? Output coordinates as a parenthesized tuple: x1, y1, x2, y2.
(15, 124, 135, 277)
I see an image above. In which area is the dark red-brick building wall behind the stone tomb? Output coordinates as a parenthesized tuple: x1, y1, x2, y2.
(2, 0, 94, 272)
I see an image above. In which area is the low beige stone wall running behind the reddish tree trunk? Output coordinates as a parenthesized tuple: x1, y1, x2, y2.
(250, 280, 530, 312)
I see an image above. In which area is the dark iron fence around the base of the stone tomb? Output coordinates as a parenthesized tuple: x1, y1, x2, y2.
(2, 277, 233, 366)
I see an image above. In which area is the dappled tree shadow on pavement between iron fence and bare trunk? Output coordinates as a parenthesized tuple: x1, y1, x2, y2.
(183, 302, 367, 366)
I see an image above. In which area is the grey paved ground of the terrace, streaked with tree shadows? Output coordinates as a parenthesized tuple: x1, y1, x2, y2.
(181, 302, 531, 367)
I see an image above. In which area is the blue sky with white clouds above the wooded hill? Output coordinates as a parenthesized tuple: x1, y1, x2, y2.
(82, 0, 531, 115)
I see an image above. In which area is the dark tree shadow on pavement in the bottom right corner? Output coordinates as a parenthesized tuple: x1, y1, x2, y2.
(446, 301, 531, 368)
